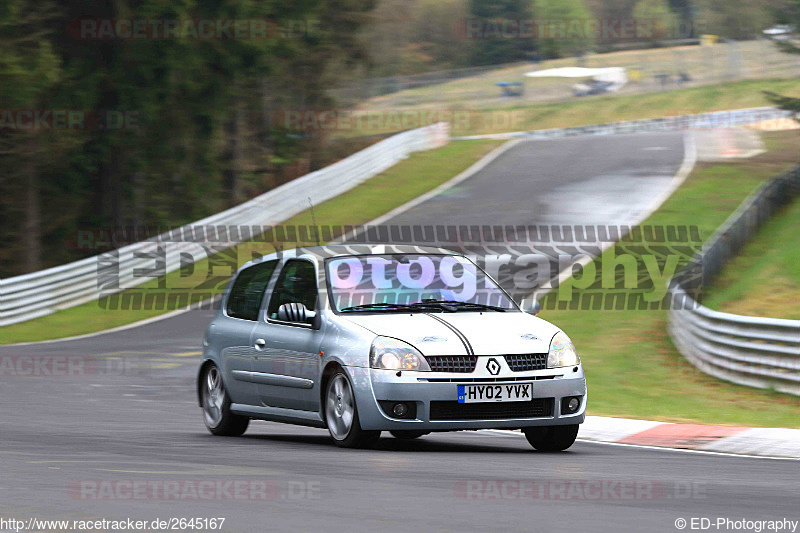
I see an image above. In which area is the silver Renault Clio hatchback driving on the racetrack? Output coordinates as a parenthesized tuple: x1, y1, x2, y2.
(197, 245, 586, 451)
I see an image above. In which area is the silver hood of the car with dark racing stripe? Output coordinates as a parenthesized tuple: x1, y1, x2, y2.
(346, 311, 559, 355)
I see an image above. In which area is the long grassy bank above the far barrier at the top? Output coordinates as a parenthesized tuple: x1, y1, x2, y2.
(340, 78, 800, 136)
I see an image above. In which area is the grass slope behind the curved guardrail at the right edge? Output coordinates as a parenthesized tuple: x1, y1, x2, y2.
(703, 192, 800, 320)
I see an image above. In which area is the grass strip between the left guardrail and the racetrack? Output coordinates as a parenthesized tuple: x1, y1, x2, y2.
(0, 140, 502, 344)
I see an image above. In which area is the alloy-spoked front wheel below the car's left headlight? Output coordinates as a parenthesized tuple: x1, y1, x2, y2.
(325, 370, 381, 448)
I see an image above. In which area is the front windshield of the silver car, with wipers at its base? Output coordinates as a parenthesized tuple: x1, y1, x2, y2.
(326, 254, 518, 313)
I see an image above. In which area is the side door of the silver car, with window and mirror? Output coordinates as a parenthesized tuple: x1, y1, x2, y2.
(251, 259, 325, 411)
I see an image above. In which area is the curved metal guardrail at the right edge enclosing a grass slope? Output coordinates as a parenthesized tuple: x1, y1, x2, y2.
(668, 167, 800, 395)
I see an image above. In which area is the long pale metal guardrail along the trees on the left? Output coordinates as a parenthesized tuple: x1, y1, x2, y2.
(0, 122, 450, 326)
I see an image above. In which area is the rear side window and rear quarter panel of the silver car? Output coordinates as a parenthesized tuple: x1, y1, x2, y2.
(220, 259, 278, 405)
